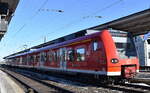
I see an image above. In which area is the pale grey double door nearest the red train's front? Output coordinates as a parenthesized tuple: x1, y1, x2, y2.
(60, 48, 67, 70)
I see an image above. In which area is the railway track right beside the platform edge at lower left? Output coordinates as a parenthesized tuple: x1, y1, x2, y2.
(1, 69, 73, 93)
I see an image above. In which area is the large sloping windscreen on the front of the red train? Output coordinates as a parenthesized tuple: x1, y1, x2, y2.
(112, 32, 137, 59)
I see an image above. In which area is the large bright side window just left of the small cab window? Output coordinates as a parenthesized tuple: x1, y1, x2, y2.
(77, 48, 85, 61)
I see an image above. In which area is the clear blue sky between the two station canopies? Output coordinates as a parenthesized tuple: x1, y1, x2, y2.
(0, 0, 150, 60)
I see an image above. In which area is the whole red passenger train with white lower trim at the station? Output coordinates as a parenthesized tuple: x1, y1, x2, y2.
(5, 30, 139, 83)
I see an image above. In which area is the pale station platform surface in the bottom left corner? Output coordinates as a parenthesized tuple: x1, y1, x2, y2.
(0, 70, 24, 93)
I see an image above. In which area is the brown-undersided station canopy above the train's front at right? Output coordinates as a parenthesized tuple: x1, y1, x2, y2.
(88, 9, 150, 35)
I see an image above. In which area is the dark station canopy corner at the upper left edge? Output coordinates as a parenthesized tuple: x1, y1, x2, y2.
(0, 0, 20, 40)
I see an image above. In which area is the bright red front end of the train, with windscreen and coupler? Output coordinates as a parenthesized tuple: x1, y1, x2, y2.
(101, 31, 139, 79)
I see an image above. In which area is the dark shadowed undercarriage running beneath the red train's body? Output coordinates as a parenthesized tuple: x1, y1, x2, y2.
(2, 65, 135, 85)
